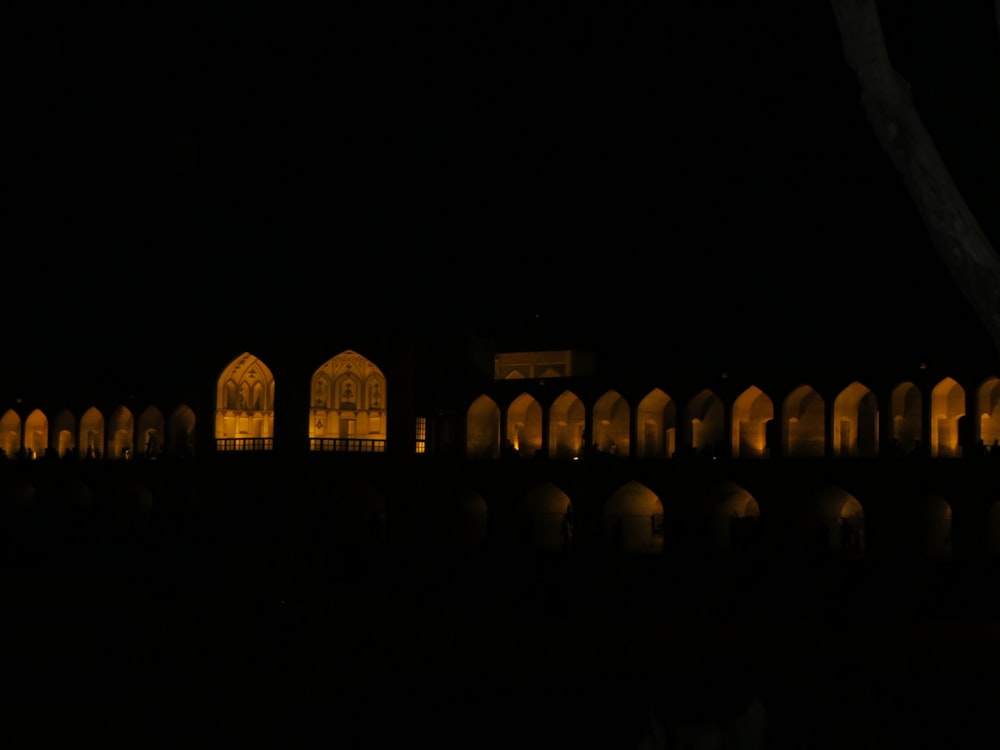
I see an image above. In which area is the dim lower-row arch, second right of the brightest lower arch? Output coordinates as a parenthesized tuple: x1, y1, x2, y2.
(800, 484, 866, 559)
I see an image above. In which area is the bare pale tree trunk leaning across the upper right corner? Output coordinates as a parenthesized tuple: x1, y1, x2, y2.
(830, 0, 1000, 352)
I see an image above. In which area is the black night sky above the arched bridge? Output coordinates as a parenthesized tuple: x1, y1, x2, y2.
(4, 0, 1000, 370)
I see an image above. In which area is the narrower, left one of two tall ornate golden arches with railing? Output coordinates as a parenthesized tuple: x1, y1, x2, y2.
(215, 352, 274, 451)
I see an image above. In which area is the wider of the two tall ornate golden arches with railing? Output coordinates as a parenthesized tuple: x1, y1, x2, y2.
(309, 349, 388, 453)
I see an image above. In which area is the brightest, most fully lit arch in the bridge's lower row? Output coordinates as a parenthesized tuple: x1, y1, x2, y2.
(601, 480, 663, 555)
